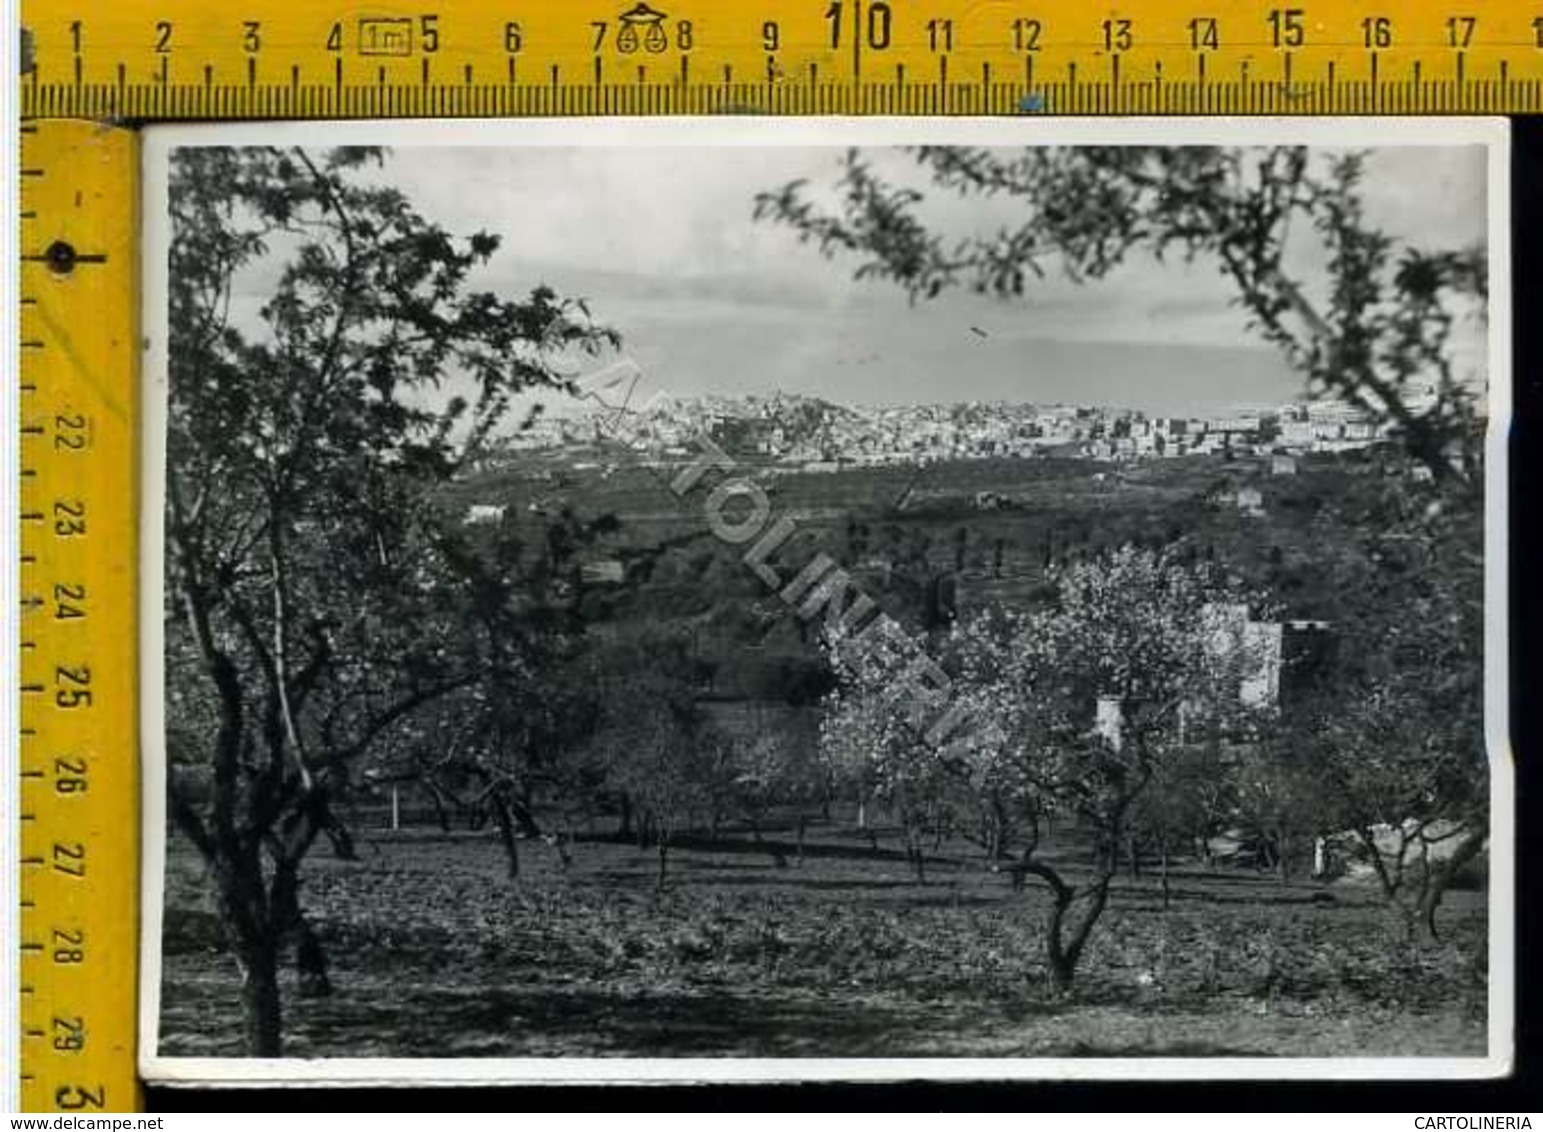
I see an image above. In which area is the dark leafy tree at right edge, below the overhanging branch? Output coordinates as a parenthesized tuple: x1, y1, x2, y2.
(1302, 478, 1489, 939)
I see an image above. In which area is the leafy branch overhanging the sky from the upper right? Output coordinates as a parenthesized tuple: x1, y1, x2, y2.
(756, 147, 1487, 481)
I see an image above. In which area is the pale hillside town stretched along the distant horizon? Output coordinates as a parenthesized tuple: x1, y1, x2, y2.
(508, 389, 1437, 472)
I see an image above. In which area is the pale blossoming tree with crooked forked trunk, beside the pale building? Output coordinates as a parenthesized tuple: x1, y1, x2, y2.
(944, 547, 1261, 993)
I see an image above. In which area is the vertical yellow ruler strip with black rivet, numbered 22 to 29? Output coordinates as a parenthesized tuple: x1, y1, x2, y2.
(19, 122, 139, 1112)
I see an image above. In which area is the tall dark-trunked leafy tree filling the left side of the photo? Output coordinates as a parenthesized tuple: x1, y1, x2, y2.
(165, 148, 616, 1056)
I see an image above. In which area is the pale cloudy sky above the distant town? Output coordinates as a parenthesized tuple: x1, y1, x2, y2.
(225, 147, 1486, 413)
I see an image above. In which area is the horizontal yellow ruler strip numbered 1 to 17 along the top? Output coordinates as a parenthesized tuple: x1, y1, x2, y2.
(22, 0, 1543, 120)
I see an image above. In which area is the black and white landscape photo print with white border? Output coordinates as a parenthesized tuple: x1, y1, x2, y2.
(140, 119, 1514, 1084)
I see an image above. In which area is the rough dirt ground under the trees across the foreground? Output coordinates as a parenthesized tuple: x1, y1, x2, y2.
(160, 828, 1486, 1056)
